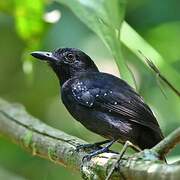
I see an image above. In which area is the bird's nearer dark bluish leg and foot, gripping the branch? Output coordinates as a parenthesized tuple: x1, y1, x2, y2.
(83, 139, 117, 161)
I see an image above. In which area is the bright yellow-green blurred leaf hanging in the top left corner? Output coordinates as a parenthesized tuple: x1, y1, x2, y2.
(15, 0, 44, 40)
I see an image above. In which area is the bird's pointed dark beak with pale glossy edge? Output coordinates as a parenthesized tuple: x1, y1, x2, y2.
(31, 51, 58, 62)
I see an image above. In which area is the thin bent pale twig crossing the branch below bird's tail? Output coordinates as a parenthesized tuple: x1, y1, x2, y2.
(105, 141, 141, 180)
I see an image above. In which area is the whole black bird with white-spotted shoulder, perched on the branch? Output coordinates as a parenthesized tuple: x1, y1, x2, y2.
(31, 48, 163, 156)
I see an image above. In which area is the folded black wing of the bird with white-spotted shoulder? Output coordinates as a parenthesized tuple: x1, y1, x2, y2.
(73, 76, 161, 133)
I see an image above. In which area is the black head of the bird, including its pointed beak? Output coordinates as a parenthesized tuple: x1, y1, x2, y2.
(31, 48, 98, 84)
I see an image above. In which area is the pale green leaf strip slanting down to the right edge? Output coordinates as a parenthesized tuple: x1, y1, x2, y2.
(121, 22, 180, 89)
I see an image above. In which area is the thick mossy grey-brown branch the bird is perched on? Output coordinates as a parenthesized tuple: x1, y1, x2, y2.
(0, 99, 180, 180)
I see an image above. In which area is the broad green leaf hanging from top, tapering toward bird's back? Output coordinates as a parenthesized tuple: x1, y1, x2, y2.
(56, 0, 134, 85)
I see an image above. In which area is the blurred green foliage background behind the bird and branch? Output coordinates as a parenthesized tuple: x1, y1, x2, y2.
(0, 0, 180, 180)
